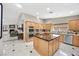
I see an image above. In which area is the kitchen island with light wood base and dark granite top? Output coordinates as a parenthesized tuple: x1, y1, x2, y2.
(33, 34, 60, 56)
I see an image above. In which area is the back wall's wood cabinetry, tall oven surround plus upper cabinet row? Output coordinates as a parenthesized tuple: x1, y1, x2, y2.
(24, 21, 52, 42)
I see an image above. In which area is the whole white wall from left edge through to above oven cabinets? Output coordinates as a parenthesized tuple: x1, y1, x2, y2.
(3, 4, 42, 25)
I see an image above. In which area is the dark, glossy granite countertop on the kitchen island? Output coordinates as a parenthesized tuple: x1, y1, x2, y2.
(35, 34, 60, 41)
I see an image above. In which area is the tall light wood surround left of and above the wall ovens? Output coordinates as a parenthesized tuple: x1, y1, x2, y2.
(23, 21, 35, 42)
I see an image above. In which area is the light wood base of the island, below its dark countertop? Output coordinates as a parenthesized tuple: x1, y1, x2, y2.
(33, 37, 59, 56)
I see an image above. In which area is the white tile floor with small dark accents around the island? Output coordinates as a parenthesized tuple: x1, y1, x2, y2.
(0, 31, 79, 56)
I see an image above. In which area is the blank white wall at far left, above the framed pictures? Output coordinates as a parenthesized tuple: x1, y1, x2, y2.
(3, 4, 19, 25)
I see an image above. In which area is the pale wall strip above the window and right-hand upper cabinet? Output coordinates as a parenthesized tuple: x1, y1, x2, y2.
(43, 15, 79, 24)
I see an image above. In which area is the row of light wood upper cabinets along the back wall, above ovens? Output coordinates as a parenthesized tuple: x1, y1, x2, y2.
(25, 21, 53, 30)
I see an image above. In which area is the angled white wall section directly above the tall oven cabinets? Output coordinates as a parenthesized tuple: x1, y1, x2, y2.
(18, 13, 42, 24)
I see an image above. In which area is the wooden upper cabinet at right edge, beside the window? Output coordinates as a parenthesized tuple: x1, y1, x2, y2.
(69, 19, 79, 31)
